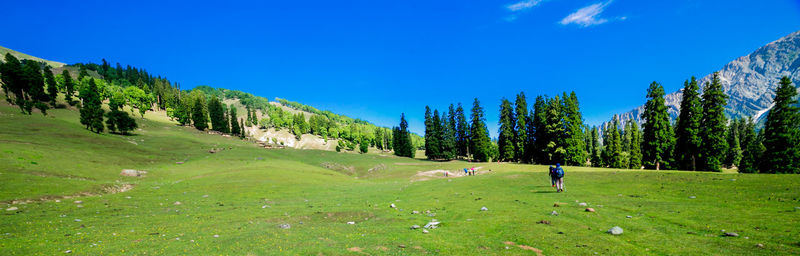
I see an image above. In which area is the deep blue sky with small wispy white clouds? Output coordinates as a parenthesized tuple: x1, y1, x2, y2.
(0, 0, 800, 137)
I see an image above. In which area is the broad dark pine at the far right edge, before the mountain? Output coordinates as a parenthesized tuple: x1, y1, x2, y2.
(760, 76, 800, 173)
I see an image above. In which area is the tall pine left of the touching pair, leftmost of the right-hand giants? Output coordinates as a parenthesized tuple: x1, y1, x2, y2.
(640, 82, 674, 170)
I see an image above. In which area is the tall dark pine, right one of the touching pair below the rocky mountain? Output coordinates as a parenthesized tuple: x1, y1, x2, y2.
(700, 72, 728, 172)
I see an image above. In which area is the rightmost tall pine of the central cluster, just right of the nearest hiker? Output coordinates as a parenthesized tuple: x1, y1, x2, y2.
(563, 92, 586, 166)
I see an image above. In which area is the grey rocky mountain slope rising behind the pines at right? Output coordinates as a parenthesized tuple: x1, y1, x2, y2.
(621, 31, 800, 123)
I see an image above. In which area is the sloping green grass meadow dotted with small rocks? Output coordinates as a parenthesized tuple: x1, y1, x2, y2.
(0, 103, 800, 255)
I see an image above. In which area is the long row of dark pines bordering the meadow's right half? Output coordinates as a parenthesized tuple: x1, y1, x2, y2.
(424, 73, 800, 173)
